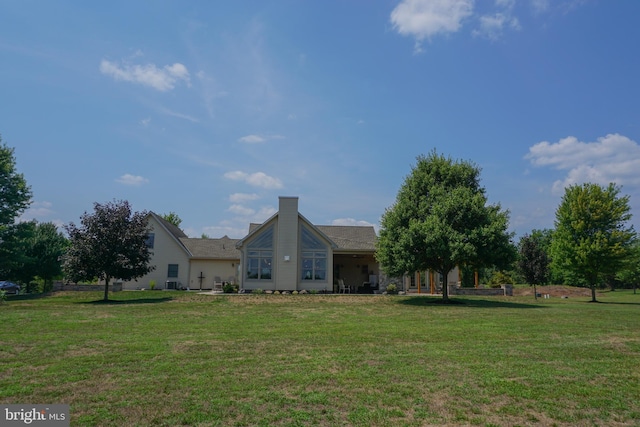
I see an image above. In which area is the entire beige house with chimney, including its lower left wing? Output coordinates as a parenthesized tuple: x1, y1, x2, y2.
(123, 197, 380, 292)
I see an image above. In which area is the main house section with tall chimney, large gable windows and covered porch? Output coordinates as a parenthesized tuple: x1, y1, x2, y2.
(236, 197, 380, 292)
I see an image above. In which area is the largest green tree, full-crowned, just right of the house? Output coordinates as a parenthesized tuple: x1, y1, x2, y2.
(377, 151, 515, 301)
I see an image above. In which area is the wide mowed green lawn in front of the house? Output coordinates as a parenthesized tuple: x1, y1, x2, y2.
(0, 291, 640, 426)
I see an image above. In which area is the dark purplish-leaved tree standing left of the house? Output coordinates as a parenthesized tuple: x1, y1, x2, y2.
(63, 201, 154, 301)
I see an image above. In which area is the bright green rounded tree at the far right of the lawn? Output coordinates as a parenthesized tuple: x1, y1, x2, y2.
(551, 183, 636, 302)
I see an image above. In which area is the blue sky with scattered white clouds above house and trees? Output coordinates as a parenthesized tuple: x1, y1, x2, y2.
(0, 0, 640, 238)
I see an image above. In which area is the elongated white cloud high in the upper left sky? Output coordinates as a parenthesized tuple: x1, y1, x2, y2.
(100, 59, 190, 92)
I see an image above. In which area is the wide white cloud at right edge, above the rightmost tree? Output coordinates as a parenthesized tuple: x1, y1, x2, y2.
(525, 134, 640, 194)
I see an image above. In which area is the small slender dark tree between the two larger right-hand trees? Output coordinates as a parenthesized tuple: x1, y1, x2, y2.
(517, 233, 550, 299)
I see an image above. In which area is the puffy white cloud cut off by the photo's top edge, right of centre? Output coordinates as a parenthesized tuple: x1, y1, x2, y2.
(391, 0, 474, 50)
